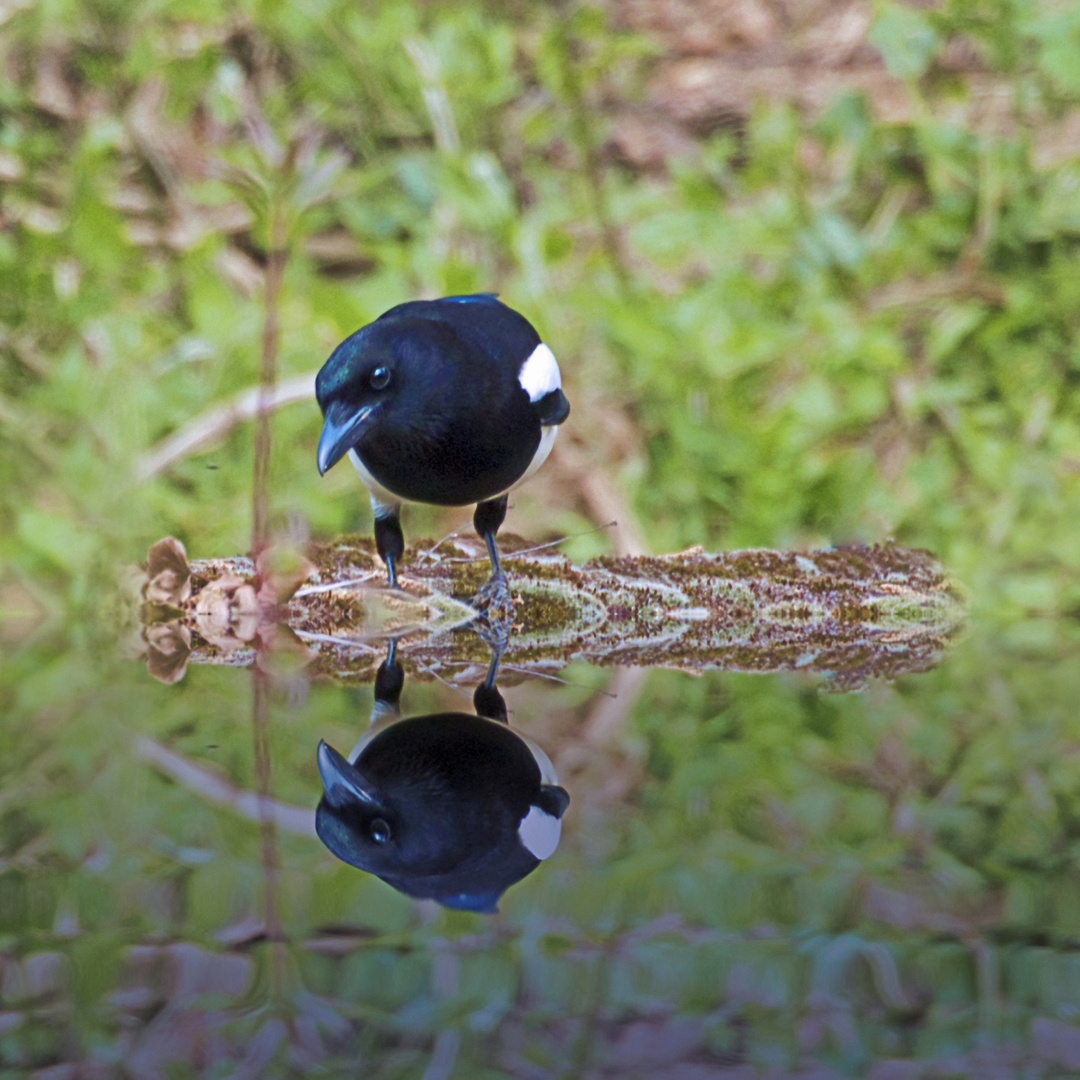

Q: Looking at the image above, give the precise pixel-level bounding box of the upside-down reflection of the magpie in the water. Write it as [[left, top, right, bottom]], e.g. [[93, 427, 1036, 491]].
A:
[[315, 646, 570, 913]]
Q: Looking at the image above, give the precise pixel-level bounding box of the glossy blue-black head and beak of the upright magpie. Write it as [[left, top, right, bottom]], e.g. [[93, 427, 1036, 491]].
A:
[[315, 316, 461, 474]]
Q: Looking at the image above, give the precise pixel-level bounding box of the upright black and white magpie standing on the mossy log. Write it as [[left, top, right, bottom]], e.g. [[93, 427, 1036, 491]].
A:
[[315, 293, 570, 588]]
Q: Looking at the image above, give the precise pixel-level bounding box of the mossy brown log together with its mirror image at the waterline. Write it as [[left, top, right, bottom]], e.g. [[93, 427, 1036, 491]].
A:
[[132, 536, 964, 689]]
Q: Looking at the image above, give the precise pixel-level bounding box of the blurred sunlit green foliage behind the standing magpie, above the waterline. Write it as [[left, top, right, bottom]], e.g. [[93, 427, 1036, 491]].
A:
[[0, 0, 1080, 630]]
